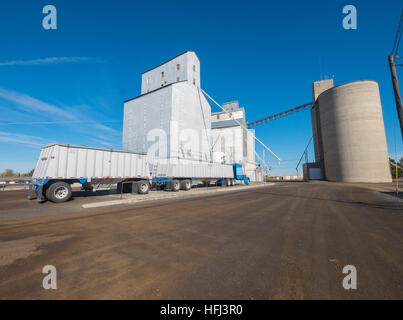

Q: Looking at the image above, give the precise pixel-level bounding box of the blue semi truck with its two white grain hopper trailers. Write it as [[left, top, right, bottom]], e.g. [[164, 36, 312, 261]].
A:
[[28, 143, 249, 203]]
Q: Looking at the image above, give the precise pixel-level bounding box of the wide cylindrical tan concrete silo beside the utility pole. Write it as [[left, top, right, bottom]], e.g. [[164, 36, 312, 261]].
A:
[[318, 81, 392, 182]]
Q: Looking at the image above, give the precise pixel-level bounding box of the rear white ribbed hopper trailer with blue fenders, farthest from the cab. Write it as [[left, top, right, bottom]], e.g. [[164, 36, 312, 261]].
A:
[[28, 143, 150, 202]]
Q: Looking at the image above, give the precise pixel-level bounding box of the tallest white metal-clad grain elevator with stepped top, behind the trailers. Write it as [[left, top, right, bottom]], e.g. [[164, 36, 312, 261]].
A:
[[123, 51, 211, 163]]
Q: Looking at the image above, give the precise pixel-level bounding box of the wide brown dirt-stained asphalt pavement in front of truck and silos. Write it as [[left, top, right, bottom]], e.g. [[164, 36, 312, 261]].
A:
[[0, 182, 403, 299]]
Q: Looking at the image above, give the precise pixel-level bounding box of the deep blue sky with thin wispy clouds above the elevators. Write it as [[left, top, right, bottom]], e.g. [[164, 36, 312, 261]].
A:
[[0, 0, 403, 173]]
